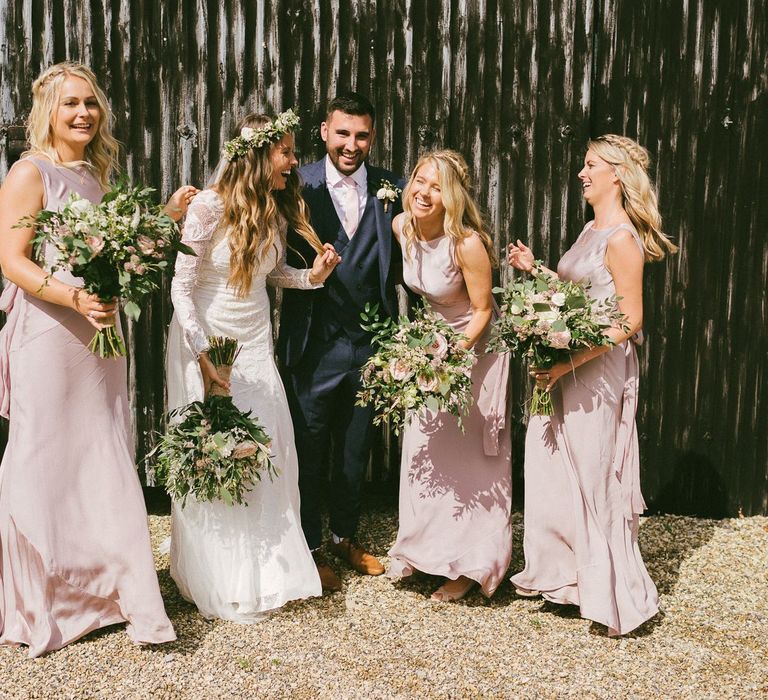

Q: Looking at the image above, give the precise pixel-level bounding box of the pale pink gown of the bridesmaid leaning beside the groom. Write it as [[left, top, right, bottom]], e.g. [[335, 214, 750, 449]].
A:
[[388, 234, 512, 596]]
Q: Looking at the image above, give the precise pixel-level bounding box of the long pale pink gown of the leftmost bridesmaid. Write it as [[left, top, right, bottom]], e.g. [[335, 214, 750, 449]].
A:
[[0, 157, 175, 657]]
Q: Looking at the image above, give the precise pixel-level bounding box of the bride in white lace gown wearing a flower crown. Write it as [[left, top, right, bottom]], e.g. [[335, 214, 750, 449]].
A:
[[167, 110, 340, 623]]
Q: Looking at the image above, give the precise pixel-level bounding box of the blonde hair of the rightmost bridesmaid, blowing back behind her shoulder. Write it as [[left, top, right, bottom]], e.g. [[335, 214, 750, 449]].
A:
[[589, 134, 678, 261]]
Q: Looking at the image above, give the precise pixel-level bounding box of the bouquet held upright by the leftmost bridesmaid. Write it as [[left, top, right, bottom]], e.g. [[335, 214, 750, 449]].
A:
[[17, 181, 194, 358]]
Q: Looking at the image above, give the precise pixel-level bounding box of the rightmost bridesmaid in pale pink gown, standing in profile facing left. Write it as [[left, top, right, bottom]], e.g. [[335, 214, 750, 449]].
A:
[[509, 134, 677, 635]]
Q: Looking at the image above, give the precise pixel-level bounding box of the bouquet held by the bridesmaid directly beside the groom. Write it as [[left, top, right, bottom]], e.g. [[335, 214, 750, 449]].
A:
[[357, 302, 475, 434]]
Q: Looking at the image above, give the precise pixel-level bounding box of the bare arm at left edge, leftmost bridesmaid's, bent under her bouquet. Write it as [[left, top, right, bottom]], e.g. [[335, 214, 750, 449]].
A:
[[0, 161, 117, 328]]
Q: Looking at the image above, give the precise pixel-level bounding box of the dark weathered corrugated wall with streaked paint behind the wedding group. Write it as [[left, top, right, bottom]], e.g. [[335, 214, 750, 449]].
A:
[[0, 0, 768, 515]]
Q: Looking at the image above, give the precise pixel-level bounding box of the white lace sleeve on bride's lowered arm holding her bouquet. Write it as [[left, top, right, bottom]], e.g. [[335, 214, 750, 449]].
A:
[[171, 191, 221, 357]]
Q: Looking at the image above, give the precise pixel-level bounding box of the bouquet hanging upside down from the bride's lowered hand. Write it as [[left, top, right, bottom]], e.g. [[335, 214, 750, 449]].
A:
[[146, 336, 278, 507]]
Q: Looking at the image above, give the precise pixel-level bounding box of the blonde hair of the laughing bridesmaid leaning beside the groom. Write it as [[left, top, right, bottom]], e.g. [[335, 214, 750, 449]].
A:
[[402, 149, 498, 267]]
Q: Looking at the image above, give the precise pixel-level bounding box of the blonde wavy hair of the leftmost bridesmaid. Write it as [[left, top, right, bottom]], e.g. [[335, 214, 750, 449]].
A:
[[23, 61, 120, 189]]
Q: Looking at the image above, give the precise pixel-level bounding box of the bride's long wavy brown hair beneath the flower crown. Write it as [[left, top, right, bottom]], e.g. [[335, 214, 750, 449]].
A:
[[215, 114, 323, 298]]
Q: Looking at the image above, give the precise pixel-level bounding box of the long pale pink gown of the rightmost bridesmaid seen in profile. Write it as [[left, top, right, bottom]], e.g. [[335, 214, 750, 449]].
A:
[[512, 222, 658, 634]]
